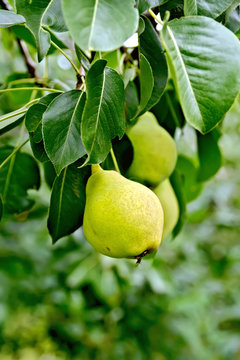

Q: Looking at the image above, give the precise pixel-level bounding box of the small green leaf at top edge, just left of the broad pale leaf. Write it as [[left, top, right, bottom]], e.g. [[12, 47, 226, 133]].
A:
[[43, 0, 68, 32]]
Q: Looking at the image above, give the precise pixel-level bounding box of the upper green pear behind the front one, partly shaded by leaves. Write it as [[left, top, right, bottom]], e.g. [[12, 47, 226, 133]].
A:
[[127, 112, 177, 185]]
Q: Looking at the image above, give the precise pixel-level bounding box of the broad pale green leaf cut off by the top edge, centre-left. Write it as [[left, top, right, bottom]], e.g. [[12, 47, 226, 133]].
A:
[[63, 0, 138, 52]]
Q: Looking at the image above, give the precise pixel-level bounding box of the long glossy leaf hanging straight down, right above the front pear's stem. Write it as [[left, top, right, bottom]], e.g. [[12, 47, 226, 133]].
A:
[[81, 60, 125, 164]]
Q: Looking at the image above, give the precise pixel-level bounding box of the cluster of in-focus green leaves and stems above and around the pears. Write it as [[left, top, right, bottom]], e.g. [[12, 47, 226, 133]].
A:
[[0, 0, 240, 242]]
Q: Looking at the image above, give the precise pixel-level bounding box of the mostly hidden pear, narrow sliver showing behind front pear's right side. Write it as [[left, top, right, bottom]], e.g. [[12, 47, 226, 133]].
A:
[[154, 179, 179, 239]]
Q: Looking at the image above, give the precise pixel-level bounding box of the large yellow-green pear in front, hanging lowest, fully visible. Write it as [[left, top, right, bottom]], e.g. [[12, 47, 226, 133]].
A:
[[83, 165, 163, 262]]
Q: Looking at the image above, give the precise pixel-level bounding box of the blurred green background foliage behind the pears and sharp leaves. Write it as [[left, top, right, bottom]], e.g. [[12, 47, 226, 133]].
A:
[[0, 28, 240, 360]]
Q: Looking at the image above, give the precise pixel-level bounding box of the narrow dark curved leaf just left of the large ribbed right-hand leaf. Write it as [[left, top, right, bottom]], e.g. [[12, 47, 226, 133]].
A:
[[139, 17, 168, 111]]
